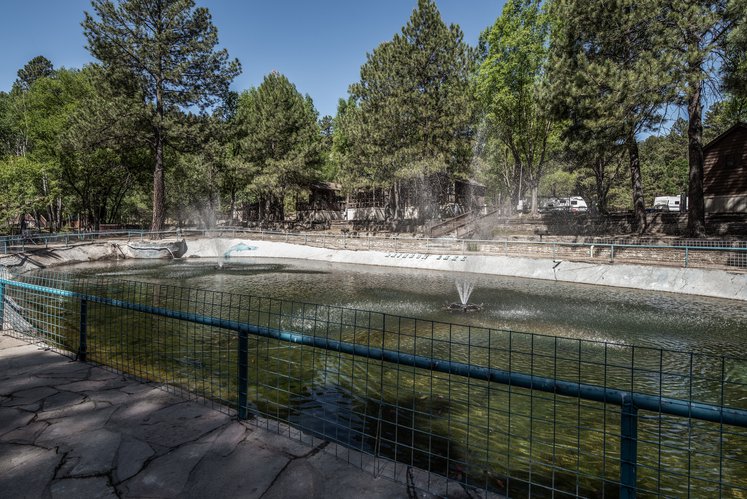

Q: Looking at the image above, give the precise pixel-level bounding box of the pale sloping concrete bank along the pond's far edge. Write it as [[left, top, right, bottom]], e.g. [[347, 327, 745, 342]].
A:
[[0, 238, 747, 301]]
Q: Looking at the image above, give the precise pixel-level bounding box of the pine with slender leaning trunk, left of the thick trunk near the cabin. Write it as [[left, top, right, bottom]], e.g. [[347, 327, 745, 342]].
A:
[[550, 0, 672, 232]]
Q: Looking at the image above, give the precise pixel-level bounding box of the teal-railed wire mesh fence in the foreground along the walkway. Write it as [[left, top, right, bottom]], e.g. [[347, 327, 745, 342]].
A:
[[0, 274, 747, 497]]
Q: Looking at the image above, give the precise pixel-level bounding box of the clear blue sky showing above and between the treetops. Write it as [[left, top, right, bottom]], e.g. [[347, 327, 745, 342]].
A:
[[0, 0, 504, 115]]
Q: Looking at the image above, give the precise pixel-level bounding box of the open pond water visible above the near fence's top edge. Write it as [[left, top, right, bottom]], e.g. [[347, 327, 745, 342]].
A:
[[60, 259, 747, 357]]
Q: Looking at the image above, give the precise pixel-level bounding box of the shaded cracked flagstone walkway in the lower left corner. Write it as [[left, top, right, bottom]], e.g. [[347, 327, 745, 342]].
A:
[[0, 334, 479, 499]]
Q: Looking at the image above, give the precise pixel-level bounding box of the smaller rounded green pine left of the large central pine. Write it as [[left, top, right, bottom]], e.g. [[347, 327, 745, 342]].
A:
[[234, 72, 322, 219]]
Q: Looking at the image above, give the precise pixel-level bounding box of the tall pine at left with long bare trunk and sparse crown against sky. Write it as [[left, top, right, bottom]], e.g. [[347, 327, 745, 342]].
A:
[[83, 0, 240, 231]]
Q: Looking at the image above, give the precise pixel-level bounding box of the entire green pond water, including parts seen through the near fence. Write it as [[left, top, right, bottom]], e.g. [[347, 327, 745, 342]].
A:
[[51, 259, 747, 497]]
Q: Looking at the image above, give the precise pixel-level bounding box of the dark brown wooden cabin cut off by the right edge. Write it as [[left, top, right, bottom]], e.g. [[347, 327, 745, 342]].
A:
[[703, 123, 747, 213]]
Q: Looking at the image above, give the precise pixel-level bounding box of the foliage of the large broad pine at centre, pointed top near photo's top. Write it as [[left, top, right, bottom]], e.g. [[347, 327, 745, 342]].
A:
[[334, 0, 475, 199]]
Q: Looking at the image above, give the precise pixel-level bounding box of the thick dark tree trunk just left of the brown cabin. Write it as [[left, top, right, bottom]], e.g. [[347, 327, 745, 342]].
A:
[[687, 83, 705, 237]]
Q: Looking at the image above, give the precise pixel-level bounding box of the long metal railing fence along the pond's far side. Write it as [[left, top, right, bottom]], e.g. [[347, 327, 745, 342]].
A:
[[5, 228, 747, 270]]
